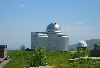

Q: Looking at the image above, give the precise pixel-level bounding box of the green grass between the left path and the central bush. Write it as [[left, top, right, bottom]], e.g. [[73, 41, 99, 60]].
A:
[[4, 50, 34, 68]]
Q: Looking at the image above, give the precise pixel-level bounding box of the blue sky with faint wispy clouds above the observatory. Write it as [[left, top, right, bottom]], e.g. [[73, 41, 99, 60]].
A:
[[0, 0, 100, 49]]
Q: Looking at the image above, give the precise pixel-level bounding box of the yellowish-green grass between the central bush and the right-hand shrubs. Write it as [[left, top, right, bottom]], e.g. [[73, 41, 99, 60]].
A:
[[47, 52, 69, 66]]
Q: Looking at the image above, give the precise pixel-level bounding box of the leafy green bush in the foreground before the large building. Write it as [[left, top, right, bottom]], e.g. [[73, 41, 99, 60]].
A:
[[30, 47, 47, 67]]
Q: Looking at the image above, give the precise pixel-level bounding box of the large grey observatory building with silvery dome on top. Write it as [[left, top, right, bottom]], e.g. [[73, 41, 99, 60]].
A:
[[31, 23, 69, 51]]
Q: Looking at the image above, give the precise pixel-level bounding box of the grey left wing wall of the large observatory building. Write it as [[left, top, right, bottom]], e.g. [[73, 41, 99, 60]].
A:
[[31, 33, 48, 50]]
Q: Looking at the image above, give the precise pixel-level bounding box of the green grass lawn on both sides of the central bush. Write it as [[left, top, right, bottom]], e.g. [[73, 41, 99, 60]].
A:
[[4, 50, 69, 68]]
